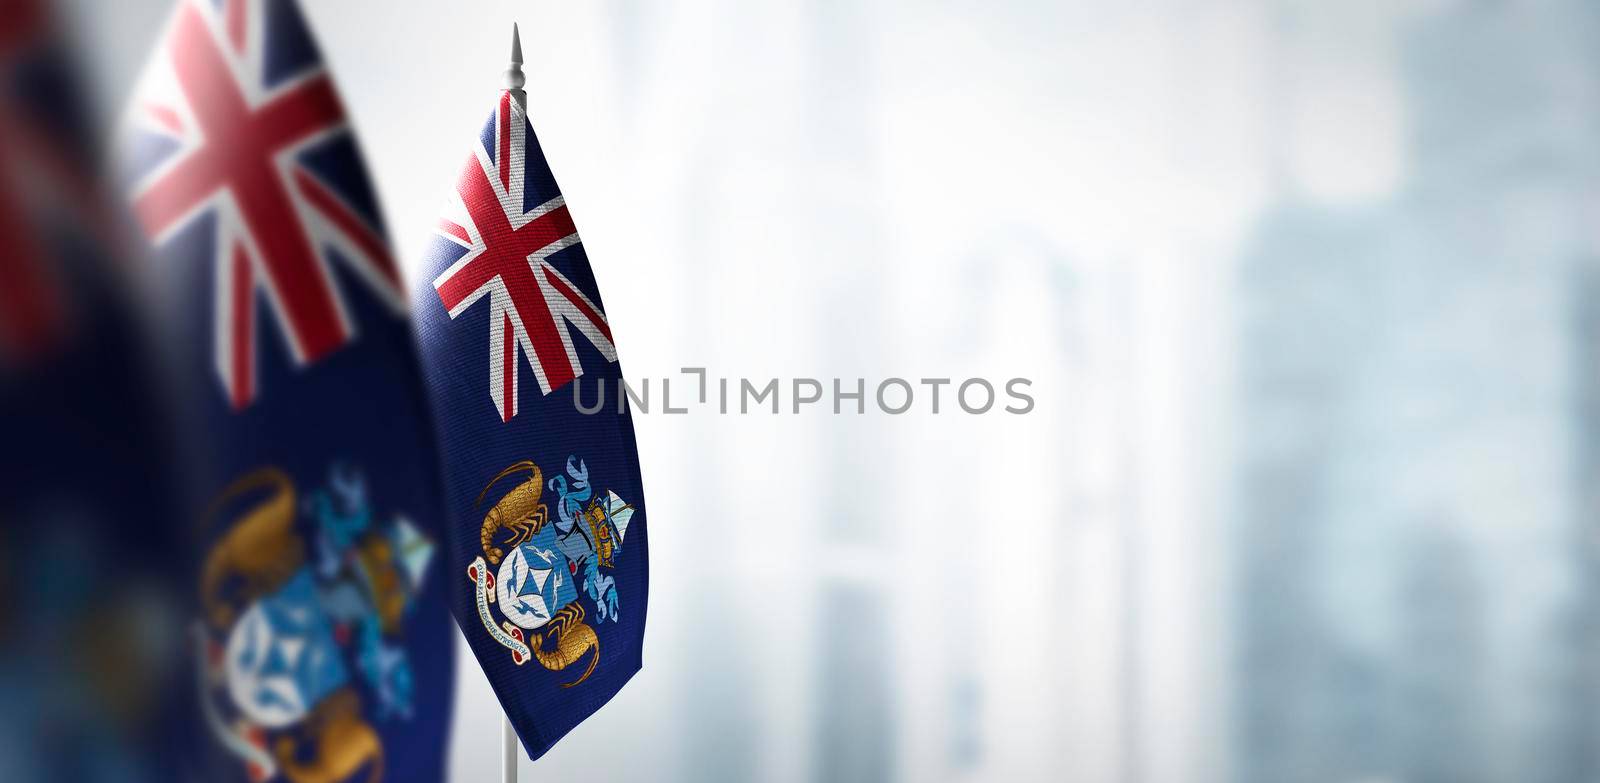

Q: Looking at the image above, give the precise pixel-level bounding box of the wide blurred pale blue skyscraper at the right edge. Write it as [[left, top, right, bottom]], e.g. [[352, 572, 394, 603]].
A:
[[1234, 0, 1600, 783]]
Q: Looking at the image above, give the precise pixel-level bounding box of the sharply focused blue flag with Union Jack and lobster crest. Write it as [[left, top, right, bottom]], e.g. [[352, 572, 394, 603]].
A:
[[413, 91, 648, 757]]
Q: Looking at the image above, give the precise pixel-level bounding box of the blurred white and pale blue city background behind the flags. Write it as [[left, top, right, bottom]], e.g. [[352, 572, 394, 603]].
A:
[[15, 0, 1600, 783]]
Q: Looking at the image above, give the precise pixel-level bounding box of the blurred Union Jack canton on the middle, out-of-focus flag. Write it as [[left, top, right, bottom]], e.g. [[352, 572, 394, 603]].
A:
[[128, 0, 405, 410]]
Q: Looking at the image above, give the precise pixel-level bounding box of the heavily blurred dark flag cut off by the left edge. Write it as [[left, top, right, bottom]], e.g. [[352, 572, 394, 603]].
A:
[[0, 0, 186, 781]]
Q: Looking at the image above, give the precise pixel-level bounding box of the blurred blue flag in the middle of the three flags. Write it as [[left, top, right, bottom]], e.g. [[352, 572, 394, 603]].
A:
[[122, 0, 454, 781]]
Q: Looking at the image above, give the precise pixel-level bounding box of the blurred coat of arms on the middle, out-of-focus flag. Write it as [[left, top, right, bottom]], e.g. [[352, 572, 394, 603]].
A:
[[195, 468, 434, 783]]
